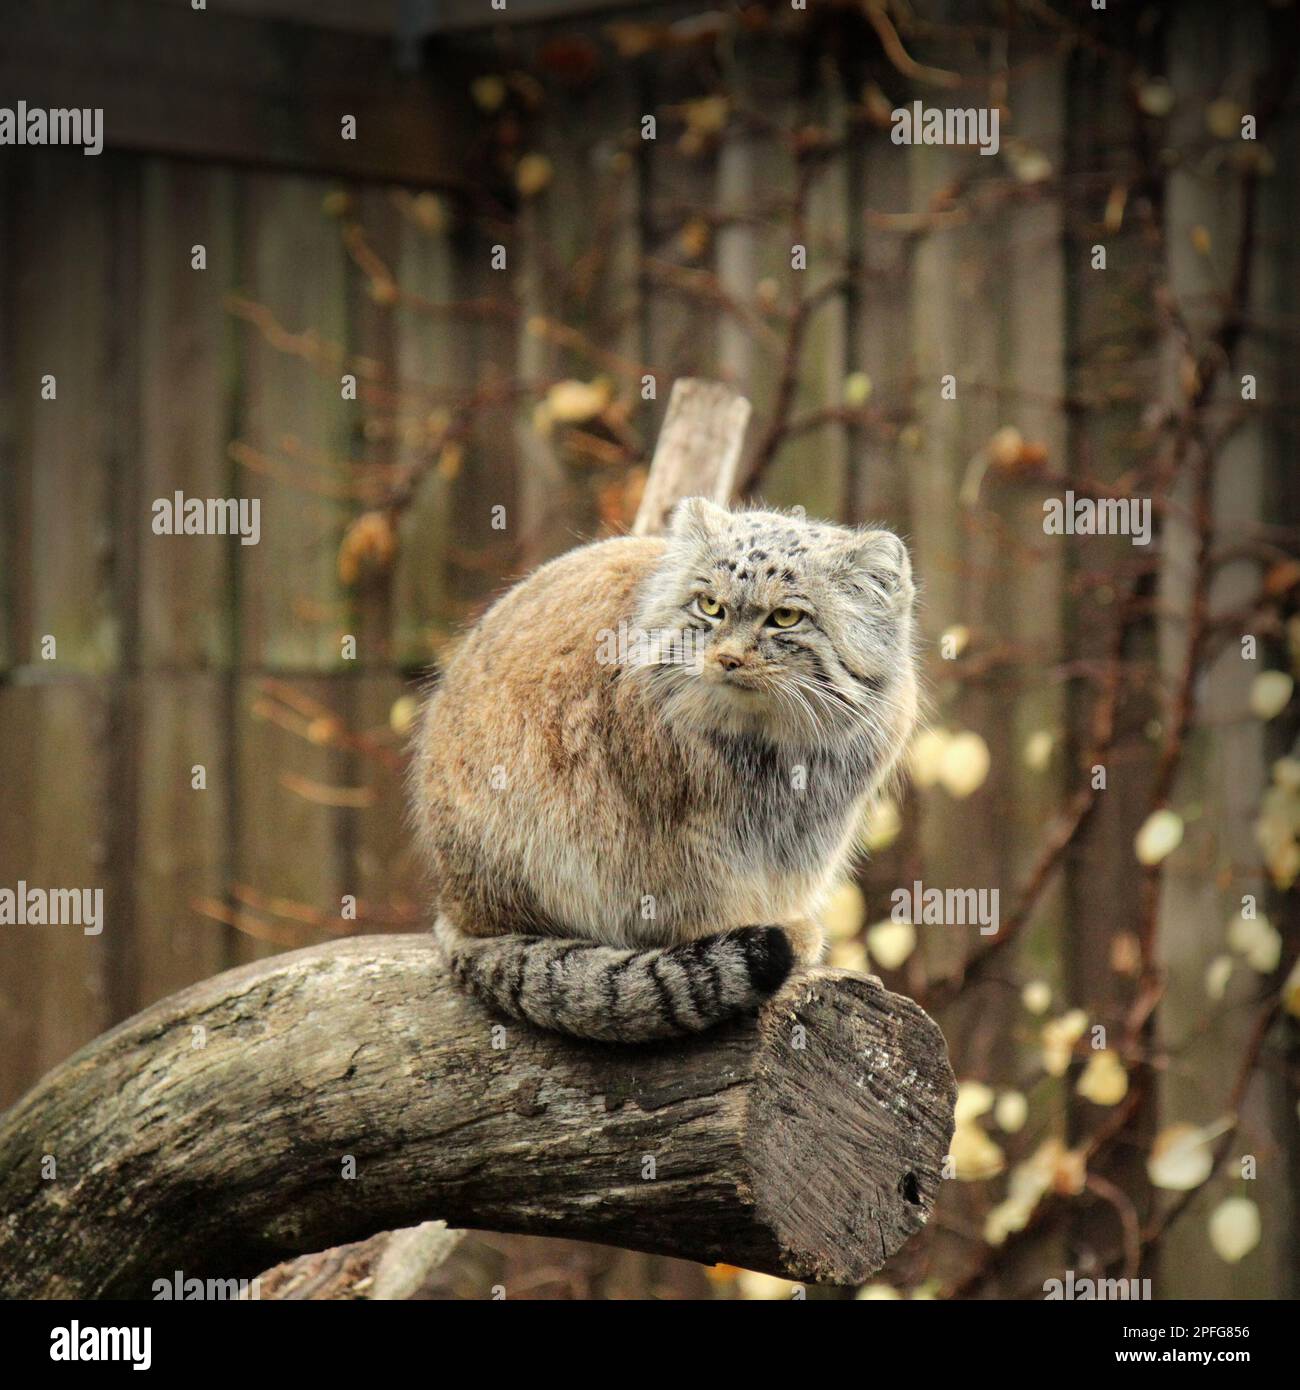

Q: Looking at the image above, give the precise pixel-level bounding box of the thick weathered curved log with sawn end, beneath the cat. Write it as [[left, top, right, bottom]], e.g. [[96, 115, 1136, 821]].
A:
[[0, 935, 954, 1297]]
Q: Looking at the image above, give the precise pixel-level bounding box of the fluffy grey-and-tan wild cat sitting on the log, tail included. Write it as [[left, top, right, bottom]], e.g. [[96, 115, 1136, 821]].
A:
[[412, 498, 918, 1041]]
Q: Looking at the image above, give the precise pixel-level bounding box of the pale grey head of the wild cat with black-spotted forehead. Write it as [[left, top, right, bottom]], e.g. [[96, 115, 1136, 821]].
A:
[[635, 498, 916, 742]]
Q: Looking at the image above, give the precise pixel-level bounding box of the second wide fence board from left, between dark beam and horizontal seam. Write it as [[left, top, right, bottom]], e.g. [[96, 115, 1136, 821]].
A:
[[138, 160, 247, 667]]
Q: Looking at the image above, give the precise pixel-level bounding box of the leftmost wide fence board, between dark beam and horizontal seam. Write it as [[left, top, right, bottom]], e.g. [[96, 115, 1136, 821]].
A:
[[11, 153, 120, 671]]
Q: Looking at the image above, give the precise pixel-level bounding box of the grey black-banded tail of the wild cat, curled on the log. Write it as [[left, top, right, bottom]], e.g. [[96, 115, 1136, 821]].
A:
[[434, 917, 794, 1043]]
